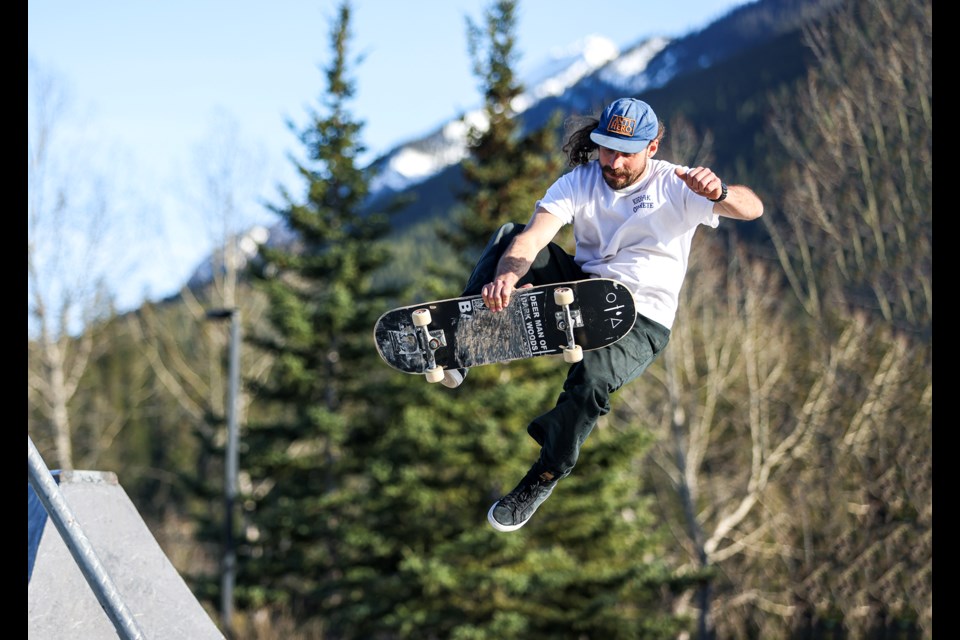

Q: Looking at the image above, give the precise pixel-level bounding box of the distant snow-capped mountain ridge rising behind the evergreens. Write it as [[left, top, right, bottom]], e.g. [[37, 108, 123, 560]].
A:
[[190, 0, 843, 286]]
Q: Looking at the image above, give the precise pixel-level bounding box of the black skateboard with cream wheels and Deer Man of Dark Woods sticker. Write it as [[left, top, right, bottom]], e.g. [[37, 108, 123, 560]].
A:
[[373, 278, 637, 382]]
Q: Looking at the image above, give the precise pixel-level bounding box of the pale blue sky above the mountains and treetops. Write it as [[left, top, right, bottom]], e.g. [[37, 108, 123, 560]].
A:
[[27, 0, 744, 306]]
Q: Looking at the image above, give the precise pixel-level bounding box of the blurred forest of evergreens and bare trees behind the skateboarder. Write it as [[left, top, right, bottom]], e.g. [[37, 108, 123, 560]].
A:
[[28, 0, 933, 640]]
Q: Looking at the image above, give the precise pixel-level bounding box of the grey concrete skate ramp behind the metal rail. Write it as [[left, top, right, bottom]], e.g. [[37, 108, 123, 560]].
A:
[[27, 471, 224, 640]]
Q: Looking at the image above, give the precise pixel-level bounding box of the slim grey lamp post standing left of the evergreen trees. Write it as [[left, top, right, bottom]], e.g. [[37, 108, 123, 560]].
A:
[[207, 309, 240, 637]]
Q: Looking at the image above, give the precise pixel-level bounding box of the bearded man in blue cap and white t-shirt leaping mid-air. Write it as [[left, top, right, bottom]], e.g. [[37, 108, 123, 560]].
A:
[[442, 98, 763, 531]]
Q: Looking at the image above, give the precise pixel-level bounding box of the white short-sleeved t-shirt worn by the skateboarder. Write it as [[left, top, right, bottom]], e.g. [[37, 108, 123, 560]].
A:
[[537, 159, 720, 329]]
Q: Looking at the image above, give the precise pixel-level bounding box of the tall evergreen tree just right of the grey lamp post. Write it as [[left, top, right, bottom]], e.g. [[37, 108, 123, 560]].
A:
[[237, 2, 400, 620]]
